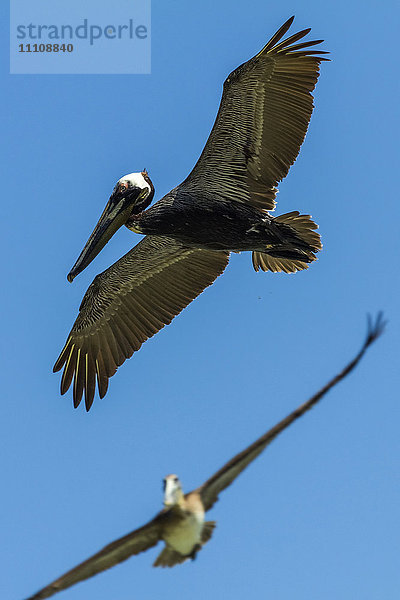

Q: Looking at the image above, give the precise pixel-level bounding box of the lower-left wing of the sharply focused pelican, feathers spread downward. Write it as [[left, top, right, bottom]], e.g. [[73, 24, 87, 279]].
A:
[[54, 236, 229, 410]]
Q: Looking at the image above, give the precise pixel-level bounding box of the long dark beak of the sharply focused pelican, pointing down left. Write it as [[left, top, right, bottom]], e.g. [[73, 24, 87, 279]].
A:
[[67, 188, 146, 282]]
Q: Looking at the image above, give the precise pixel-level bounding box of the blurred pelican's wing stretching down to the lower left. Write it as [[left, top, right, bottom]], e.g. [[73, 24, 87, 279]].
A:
[[27, 512, 165, 600]]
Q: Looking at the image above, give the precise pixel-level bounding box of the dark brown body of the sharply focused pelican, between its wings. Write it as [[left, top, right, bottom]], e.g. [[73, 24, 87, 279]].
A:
[[126, 187, 320, 255]]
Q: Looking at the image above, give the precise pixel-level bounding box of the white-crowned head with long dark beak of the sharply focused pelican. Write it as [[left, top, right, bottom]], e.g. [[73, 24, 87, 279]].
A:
[[67, 170, 154, 282]]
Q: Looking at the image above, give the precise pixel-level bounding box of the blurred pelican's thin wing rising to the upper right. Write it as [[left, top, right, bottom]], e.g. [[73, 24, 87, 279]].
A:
[[195, 313, 385, 510]]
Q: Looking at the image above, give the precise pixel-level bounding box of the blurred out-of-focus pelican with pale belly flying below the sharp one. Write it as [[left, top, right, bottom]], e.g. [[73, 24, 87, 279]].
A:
[[28, 313, 385, 600]]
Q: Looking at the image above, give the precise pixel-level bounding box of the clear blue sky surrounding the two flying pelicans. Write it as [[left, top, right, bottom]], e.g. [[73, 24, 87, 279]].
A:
[[0, 0, 400, 600]]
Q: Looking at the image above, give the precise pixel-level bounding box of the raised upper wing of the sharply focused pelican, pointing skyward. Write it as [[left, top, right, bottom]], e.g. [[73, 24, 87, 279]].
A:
[[181, 17, 326, 210]]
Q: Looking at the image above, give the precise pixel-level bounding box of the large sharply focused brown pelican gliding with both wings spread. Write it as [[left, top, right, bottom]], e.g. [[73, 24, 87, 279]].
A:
[[54, 17, 326, 410]]
